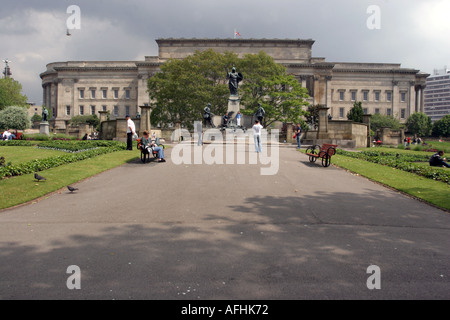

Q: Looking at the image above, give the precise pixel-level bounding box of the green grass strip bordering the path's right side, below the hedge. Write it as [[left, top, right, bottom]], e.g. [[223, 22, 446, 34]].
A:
[[332, 155, 450, 211]]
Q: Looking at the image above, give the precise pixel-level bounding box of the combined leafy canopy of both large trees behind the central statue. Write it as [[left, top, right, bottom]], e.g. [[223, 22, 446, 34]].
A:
[[148, 50, 308, 127]]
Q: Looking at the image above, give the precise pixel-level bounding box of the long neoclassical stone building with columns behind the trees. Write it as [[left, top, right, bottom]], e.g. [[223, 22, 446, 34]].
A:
[[40, 38, 429, 129]]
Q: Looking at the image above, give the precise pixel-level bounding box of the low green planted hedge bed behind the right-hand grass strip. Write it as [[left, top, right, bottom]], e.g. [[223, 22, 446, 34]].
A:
[[337, 149, 450, 184]]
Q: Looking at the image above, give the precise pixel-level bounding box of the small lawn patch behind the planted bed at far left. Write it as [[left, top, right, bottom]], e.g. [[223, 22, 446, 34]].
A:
[[0, 146, 64, 165]]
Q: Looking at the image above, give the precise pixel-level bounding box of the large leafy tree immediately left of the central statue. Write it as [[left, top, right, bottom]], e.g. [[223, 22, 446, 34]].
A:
[[148, 50, 234, 127]]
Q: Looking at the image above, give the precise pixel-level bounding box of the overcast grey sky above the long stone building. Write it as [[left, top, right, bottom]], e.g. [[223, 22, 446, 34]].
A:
[[0, 0, 450, 104]]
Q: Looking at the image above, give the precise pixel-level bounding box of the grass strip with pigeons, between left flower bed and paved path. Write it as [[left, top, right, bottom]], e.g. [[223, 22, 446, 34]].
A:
[[0, 150, 138, 210]]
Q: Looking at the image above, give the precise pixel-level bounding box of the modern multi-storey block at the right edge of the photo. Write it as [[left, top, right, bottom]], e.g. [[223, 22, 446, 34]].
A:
[[425, 68, 450, 122]]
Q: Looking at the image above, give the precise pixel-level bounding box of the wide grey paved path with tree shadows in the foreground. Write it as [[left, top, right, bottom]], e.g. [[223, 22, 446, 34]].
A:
[[0, 148, 450, 299]]
